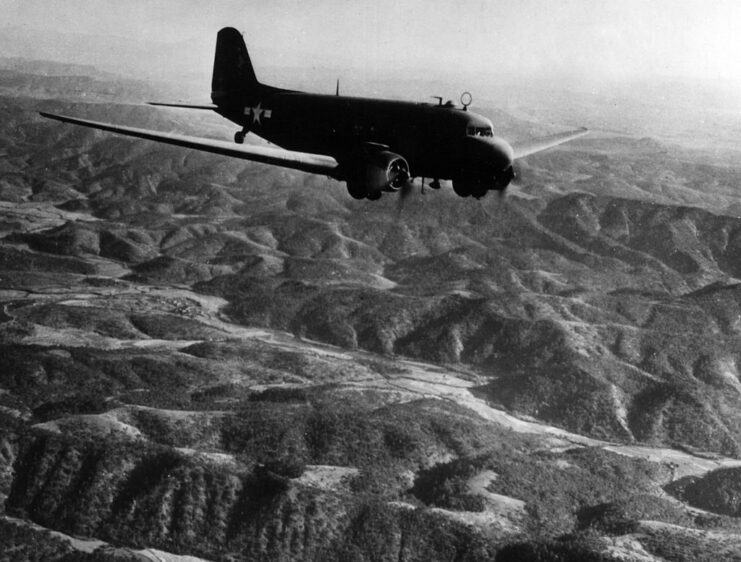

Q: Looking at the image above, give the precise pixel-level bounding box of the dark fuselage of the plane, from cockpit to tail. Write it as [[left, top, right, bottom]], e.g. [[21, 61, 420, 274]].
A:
[[217, 90, 511, 179]]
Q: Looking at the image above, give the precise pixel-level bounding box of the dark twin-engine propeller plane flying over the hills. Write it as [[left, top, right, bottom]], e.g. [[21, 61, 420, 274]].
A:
[[41, 27, 587, 200]]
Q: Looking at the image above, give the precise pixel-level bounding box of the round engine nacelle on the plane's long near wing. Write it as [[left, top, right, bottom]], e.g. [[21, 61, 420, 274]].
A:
[[346, 150, 410, 199]]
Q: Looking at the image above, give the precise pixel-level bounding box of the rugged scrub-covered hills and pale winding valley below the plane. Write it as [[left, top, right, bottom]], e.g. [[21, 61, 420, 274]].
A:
[[0, 61, 741, 561]]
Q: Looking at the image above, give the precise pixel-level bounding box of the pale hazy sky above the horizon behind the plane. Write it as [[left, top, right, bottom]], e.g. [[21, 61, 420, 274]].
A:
[[0, 0, 741, 84]]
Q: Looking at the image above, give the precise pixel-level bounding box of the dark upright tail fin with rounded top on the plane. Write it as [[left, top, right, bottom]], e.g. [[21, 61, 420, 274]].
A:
[[211, 27, 260, 105]]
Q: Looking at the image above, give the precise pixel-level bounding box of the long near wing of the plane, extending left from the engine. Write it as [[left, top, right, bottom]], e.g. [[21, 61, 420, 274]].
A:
[[39, 111, 339, 177]]
